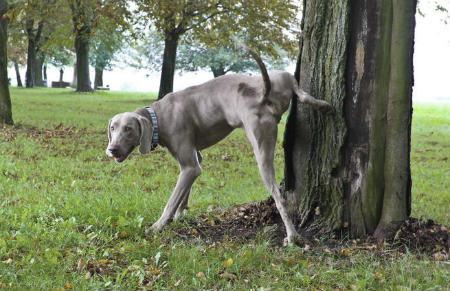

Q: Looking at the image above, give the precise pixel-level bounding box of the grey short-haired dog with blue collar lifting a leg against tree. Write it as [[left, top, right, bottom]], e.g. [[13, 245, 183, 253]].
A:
[[106, 45, 332, 244]]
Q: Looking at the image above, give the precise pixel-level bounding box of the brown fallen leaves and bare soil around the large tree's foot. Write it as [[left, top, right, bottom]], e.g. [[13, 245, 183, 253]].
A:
[[172, 197, 450, 259]]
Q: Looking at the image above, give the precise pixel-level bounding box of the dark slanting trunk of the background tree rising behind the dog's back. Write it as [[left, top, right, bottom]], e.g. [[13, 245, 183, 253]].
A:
[[158, 33, 179, 99]]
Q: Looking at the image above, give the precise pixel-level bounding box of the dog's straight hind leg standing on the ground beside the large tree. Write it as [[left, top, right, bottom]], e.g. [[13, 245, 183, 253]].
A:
[[244, 115, 299, 245]]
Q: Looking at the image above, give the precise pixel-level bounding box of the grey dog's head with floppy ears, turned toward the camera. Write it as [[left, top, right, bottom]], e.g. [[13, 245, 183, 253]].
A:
[[106, 112, 153, 163]]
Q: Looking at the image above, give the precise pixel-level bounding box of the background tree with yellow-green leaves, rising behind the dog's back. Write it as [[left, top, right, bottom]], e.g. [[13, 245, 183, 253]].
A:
[[135, 0, 298, 99]]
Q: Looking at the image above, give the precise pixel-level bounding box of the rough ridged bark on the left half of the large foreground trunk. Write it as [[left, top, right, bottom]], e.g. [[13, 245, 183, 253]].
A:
[[285, 0, 349, 231]]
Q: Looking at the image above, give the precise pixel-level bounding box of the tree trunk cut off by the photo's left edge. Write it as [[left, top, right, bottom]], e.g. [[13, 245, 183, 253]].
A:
[[0, 0, 14, 125]]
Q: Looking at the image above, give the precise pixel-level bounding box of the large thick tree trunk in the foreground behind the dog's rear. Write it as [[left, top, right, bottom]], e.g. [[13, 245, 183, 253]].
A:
[[284, 0, 415, 238]]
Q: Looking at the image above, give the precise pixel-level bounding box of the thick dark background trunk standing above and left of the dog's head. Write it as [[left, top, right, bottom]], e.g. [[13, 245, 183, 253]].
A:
[[75, 30, 92, 92]]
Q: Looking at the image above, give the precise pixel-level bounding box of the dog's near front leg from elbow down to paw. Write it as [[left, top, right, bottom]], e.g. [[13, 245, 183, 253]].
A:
[[149, 150, 202, 231]]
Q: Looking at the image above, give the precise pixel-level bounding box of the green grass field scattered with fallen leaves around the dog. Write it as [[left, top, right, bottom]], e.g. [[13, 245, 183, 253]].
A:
[[0, 88, 450, 290]]
